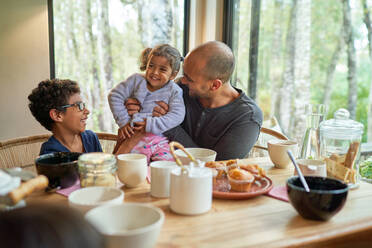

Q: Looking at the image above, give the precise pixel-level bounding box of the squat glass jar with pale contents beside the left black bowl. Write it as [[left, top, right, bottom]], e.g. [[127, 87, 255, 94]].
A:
[[78, 152, 117, 187]]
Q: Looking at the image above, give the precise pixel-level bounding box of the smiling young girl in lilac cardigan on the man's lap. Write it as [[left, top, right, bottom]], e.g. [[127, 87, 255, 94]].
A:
[[108, 44, 185, 162]]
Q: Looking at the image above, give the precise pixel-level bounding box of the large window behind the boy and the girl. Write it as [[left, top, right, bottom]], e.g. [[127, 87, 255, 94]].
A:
[[49, 0, 187, 132]]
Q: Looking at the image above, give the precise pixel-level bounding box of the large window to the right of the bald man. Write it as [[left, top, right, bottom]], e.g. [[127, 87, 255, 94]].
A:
[[228, 0, 372, 142]]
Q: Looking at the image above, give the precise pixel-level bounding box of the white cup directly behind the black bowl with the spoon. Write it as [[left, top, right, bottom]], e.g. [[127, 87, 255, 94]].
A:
[[294, 159, 327, 177]]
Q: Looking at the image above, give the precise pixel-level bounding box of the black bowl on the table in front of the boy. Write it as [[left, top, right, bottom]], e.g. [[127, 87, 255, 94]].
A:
[[35, 152, 81, 189]]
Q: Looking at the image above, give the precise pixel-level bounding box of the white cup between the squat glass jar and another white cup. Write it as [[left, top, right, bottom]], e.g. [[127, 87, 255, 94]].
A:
[[117, 153, 147, 188]]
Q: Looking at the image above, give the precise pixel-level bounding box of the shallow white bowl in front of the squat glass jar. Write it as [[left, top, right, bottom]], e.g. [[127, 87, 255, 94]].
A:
[[68, 186, 124, 213]]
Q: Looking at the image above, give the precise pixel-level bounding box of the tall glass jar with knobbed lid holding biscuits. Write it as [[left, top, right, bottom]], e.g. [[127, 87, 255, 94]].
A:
[[319, 109, 364, 187]]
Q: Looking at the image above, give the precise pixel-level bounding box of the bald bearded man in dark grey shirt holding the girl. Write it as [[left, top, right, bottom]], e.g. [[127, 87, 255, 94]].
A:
[[126, 41, 262, 160]]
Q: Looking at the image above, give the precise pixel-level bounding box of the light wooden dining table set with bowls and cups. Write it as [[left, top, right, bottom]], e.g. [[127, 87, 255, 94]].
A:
[[26, 157, 372, 248]]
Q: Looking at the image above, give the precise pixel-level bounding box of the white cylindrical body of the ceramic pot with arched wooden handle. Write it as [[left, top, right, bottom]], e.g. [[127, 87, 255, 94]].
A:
[[170, 166, 213, 215]]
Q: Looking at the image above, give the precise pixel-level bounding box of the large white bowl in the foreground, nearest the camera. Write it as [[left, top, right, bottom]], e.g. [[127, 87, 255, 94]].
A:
[[85, 203, 164, 248]]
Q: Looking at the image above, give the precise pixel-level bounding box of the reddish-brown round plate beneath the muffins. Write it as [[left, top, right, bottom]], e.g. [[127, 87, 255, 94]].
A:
[[213, 177, 273, 200]]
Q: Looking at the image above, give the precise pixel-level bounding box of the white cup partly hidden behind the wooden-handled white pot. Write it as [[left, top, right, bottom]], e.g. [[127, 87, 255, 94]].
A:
[[150, 161, 177, 197]]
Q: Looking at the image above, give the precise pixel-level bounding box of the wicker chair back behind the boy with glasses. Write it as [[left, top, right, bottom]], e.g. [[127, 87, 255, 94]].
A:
[[0, 133, 116, 168]]
